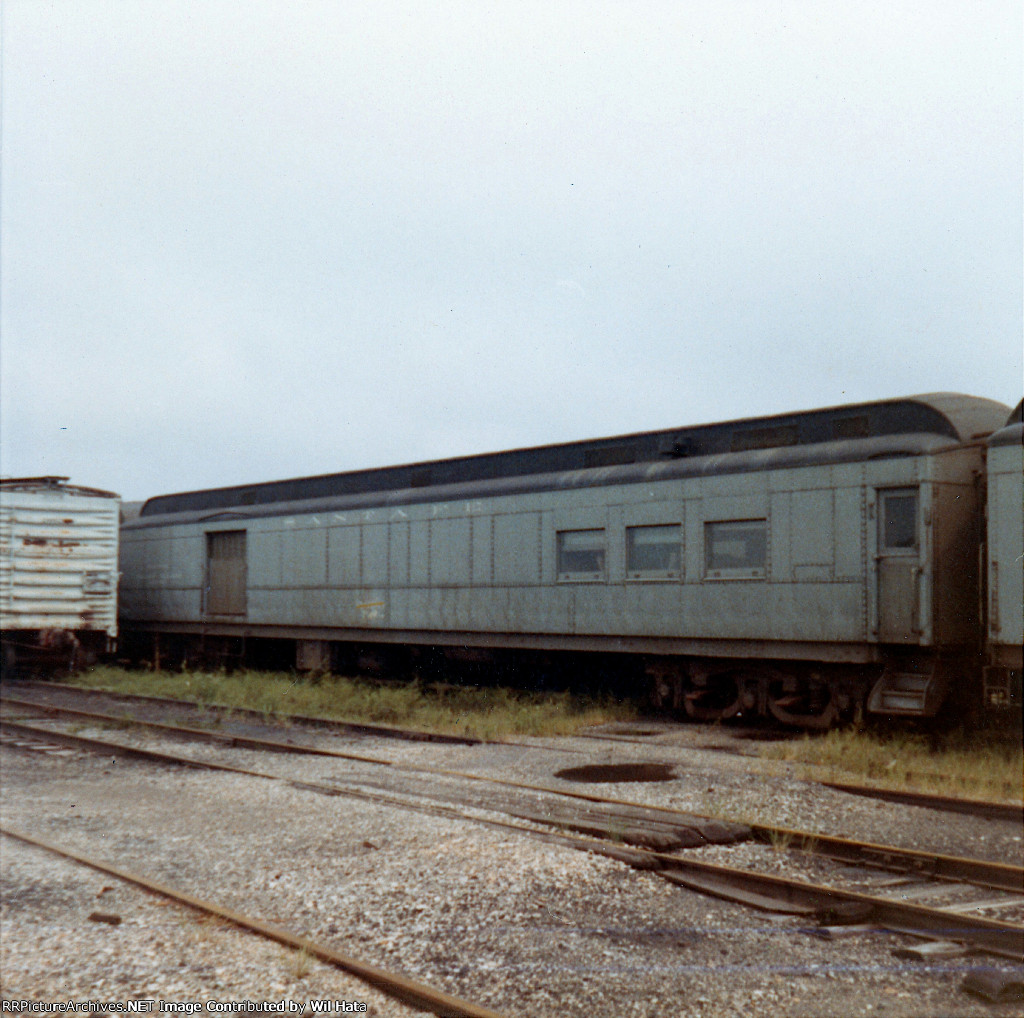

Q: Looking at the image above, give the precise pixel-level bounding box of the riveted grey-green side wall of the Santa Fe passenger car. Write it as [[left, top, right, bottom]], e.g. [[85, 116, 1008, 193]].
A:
[[123, 446, 970, 653]]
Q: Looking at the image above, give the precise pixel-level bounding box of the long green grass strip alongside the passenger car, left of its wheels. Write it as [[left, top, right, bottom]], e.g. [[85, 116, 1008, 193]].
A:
[[64, 667, 637, 739]]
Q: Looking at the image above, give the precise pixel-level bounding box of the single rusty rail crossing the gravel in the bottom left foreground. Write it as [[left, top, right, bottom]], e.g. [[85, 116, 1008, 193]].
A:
[[0, 826, 502, 1018]]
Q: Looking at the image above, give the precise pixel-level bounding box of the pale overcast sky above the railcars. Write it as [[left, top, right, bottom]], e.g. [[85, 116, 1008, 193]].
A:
[[0, 0, 1024, 499]]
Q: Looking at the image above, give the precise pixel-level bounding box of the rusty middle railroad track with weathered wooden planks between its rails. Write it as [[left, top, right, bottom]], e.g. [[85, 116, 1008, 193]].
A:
[[2, 704, 1024, 961]]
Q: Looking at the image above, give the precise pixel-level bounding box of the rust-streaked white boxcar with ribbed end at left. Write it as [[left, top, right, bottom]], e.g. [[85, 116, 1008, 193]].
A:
[[0, 477, 120, 670]]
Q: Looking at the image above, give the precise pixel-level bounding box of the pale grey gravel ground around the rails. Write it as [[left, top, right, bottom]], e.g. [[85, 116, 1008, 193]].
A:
[[0, 712, 1021, 1018]]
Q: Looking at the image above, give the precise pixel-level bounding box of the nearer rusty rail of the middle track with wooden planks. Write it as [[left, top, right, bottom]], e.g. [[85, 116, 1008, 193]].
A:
[[0, 722, 1024, 962]]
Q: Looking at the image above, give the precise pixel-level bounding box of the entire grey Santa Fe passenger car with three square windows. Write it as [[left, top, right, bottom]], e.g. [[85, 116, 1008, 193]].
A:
[[122, 394, 1009, 726]]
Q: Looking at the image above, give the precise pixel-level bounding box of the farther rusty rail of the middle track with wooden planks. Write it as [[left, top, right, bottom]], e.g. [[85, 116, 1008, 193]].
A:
[[0, 697, 1024, 892]]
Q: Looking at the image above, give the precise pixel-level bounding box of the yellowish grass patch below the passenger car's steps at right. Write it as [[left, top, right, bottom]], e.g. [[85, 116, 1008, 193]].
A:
[[761, 727, 1024, 802]]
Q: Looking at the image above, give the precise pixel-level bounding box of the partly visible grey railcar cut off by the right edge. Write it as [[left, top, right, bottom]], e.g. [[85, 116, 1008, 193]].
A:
[[984, 404, 1024, 707]]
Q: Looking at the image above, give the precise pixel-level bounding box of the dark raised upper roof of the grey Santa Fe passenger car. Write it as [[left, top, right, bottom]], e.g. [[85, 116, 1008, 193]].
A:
[[140, 392, 1010, 517]]
